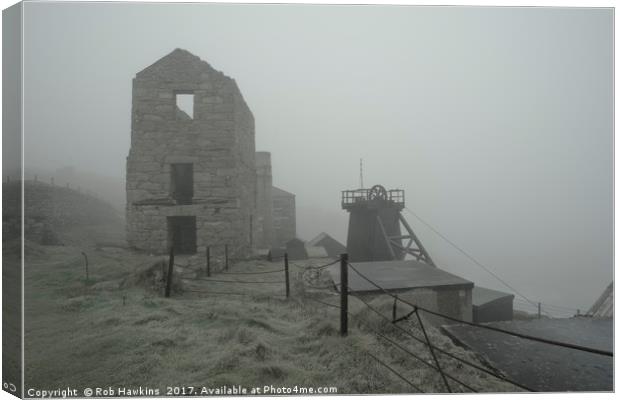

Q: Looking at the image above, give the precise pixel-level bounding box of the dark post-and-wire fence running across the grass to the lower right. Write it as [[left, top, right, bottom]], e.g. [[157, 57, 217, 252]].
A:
[[160, 253, 613, 393]]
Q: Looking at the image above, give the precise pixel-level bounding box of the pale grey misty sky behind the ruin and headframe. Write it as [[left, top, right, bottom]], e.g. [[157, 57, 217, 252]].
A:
[[17, 3, 613, 310]]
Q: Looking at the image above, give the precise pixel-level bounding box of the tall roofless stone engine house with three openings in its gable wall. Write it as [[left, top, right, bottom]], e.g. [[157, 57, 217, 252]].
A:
[[126, 49, 257, 255]]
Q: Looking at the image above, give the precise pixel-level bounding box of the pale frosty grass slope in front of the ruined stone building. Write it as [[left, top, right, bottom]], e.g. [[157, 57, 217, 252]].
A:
[[25, 239, 517, 394]]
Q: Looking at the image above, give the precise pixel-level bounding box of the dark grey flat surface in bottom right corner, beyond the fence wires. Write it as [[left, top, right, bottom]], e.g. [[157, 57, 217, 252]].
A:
[[444, 318, 613, 392]]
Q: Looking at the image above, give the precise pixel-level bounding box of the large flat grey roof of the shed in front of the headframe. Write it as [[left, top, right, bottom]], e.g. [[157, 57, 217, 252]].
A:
[[329, 260, 474, 292]]
